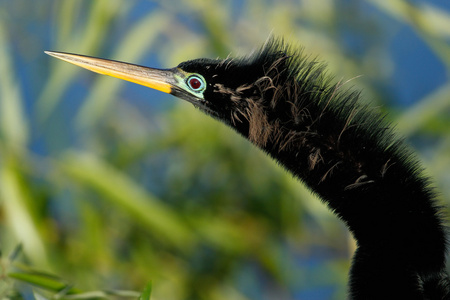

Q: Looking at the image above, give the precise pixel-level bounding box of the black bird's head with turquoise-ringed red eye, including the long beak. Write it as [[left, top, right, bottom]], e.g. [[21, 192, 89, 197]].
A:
[[46, 42, 296, 142]]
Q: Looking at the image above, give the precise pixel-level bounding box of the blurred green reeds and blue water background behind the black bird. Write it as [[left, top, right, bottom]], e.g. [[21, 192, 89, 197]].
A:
[[0, 0, 450, 300]]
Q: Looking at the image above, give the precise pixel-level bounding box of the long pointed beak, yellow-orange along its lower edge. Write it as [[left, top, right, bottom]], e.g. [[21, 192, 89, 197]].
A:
[[45, 51, 181, 94]]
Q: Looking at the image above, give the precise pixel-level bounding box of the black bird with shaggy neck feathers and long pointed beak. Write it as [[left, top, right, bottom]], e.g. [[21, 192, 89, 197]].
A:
[[47, 39, 450, 300]]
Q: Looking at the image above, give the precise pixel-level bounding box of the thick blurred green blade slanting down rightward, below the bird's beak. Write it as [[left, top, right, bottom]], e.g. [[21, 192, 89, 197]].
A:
[[60, 152, 194, 251]]
